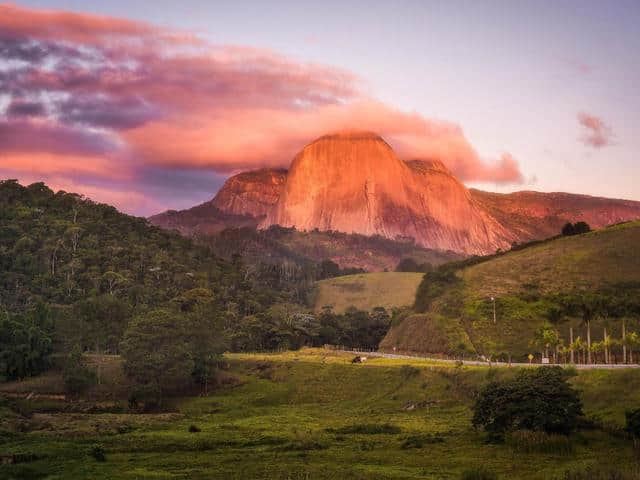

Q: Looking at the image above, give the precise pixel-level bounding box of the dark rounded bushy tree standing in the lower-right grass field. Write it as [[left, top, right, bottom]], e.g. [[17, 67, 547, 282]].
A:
[[472, 367, 582, 439]]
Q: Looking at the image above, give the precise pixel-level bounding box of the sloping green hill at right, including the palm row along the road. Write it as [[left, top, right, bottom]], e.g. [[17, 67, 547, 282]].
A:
[[381, 221, 640, 363]]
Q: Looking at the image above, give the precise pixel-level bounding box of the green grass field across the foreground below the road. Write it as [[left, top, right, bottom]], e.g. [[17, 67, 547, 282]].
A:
[[0, 349, 640, 480]]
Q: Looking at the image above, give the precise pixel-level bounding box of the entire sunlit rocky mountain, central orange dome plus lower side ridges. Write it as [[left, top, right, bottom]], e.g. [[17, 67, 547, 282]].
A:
[[150, 131, 640, 255]]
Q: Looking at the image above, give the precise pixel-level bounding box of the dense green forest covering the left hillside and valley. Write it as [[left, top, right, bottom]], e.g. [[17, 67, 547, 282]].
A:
[[0, 180, 390, 390]]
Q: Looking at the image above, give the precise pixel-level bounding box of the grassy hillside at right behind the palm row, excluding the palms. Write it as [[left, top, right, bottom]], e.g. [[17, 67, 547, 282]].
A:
[[381, 221, 640, 360]]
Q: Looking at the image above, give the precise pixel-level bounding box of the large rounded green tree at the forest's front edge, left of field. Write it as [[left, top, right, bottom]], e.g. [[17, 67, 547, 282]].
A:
[[121, 309, 194, 403]]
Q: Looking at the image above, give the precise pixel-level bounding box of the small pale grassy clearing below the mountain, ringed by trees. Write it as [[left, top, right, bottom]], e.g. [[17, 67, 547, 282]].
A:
[[312, 272, 424, 313]]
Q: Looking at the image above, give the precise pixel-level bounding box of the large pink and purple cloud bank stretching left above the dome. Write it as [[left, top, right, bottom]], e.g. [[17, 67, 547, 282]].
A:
[[0, 5, 522, 211]]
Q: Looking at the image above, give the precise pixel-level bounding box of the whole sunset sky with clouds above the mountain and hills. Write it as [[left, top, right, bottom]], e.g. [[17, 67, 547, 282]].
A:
[[0, 0, 640, 215]]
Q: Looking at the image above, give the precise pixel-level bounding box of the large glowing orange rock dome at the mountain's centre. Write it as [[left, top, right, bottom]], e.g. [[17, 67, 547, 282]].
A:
[[261, 132, 511, 253]]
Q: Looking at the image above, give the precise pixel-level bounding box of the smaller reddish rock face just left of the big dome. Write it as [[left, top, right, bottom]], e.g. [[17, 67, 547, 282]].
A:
[[211, 168, 287, 217]]
